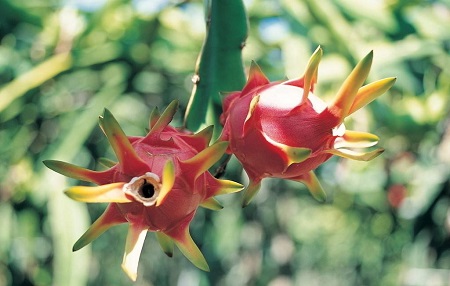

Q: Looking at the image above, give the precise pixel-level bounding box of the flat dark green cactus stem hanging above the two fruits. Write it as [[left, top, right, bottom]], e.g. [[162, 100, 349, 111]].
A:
[[185, 0, 247, 138]]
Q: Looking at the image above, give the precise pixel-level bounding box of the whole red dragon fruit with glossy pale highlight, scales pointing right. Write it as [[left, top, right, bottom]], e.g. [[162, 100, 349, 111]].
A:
[[220, 47, 396, 206]]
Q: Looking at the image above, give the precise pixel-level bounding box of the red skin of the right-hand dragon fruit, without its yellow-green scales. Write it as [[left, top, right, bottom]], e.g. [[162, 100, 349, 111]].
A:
[[221, 83, 339, 182]]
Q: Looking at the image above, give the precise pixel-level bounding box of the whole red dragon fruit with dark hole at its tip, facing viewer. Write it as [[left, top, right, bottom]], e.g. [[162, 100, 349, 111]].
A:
[[44, 101, 243, 281]]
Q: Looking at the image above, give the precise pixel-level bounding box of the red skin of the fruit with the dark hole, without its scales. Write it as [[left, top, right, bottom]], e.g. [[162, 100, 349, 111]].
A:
[[90, 126, 214, 235]]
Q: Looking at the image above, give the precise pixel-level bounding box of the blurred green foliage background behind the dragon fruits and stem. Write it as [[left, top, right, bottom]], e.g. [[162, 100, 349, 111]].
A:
[[0, 0, 450, 286]]
